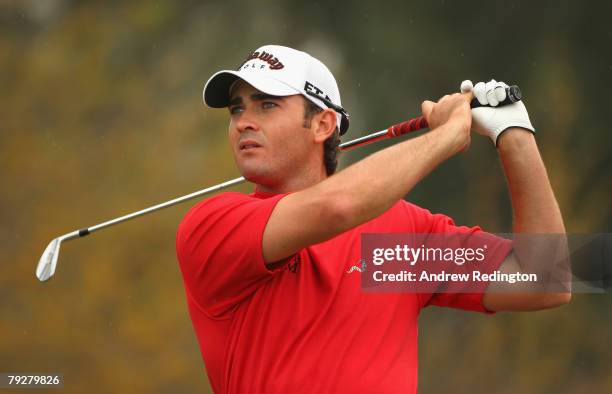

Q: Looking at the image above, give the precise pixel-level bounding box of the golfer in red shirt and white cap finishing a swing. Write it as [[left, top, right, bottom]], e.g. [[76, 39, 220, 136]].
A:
[[177, 45, 569, 393]]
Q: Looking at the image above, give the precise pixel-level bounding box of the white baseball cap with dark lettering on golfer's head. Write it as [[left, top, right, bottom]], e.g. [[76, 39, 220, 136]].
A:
[[202, 45, 349, 135]]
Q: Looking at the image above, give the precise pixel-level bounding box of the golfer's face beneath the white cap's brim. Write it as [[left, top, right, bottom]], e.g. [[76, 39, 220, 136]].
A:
[[228, 80, 314, 188]]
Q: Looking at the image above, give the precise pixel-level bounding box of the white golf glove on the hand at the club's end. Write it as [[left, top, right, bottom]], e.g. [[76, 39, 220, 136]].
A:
[[461, 79, 535, 146]]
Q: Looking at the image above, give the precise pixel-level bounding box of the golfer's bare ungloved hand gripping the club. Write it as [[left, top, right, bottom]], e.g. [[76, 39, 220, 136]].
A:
[[421, 91, 473, 155]]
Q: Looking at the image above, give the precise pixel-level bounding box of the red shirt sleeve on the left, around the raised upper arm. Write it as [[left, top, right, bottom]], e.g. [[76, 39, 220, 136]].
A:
[[176, 193, 285, 317]]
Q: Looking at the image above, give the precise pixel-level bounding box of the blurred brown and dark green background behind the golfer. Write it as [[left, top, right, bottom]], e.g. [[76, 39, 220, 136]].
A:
[[0, 0, 612, 393]]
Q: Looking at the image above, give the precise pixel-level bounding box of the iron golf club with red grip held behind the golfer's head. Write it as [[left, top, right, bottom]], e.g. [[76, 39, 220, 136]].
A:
[[36, 85, 521, 282]]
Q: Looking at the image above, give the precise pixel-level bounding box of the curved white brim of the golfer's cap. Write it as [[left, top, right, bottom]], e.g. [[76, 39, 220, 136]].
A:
[[202, 70, 301, 108]]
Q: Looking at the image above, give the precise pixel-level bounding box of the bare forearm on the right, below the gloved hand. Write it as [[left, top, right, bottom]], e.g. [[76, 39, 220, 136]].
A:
[[498, 128, 571, 309]]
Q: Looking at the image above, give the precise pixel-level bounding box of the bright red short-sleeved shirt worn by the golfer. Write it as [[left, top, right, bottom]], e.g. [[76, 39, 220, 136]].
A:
[[176, 193, 511, 394]]
